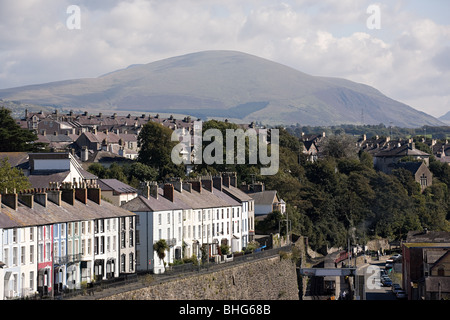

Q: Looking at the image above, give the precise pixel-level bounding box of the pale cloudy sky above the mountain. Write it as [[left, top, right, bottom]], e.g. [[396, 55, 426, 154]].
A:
[[0, 0, 450, 117]]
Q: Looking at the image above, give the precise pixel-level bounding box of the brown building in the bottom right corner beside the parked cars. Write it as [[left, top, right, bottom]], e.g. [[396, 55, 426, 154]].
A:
[[402, 230, 450, 300]]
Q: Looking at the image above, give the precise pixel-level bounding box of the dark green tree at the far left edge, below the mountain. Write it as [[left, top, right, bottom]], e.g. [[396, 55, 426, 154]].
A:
[[0, 108, 38, 152]]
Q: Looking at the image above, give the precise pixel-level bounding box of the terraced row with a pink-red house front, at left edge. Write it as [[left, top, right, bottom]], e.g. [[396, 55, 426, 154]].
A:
[[0, 183, 135, 299]]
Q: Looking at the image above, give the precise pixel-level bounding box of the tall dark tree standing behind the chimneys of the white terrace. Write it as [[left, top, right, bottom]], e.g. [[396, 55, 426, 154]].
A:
[[137, 121, 185, 179]]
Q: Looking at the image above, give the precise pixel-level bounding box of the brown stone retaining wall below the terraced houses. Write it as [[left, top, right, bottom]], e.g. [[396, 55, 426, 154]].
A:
[[104, 256, 299, 300]]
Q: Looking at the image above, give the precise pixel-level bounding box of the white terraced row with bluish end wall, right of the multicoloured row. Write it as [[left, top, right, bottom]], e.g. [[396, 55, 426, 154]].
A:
[[122, 174, 254, 273]]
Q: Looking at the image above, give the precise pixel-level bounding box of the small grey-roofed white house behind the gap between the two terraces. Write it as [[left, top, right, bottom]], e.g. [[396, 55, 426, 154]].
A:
[[98, 179, 138, 207]]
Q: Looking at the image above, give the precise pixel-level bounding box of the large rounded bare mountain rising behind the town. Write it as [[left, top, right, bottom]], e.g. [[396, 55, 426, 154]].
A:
[[0, 51, 442, 127]]
